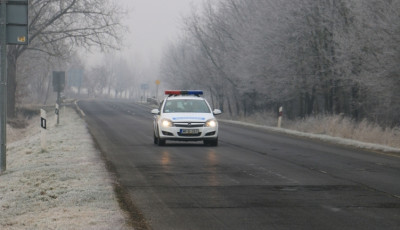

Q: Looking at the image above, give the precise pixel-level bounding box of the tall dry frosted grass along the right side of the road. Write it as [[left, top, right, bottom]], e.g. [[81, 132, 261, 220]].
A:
[[222, 112, 400, 149]]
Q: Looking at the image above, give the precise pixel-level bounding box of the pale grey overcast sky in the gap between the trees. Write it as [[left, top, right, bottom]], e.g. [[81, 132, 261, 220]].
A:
[[123, 0, 202, 58]]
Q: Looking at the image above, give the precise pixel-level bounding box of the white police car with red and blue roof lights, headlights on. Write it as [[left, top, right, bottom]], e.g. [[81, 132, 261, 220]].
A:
[[151, 90, 221, 146]]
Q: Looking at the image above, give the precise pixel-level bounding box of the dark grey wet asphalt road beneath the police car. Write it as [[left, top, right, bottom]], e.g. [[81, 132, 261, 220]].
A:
[[79, 100, 400, 230]]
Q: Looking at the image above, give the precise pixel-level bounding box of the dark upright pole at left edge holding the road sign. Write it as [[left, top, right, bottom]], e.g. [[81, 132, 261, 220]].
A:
[[0, 0, 7, 173]]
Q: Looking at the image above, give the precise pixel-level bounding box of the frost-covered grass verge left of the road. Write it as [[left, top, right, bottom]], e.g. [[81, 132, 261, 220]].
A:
[[0, 108, 129, 229]]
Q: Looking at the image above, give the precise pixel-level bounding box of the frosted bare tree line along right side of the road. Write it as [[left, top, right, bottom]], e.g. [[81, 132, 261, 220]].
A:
[[161, 0, 400, 126]]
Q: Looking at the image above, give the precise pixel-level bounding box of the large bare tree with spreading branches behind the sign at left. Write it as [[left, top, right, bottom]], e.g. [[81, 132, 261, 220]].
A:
[[7, 0, 122, 117]]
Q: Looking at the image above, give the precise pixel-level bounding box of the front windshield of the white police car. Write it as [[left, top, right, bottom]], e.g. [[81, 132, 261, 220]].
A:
[[164, 99, 210, 113]]
